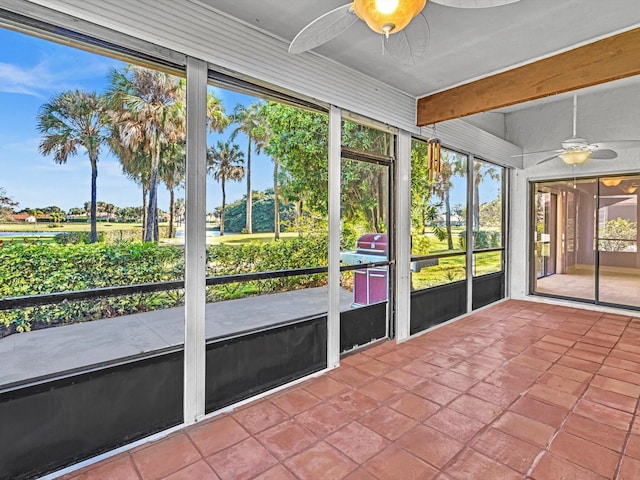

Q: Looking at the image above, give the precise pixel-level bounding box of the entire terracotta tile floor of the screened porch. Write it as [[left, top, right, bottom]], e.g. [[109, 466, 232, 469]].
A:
[[58, 301, 640, 480]]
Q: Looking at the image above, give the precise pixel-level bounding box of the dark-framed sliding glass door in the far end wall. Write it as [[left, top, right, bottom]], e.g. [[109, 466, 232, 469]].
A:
[[531, 176, 640, 308]]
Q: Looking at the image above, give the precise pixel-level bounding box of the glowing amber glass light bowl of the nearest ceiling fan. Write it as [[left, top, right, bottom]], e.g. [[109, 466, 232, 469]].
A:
[[353, 0, 427, 35]]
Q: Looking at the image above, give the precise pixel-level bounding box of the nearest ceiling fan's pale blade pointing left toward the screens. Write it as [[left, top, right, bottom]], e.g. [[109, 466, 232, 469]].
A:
[[289, 3, 358, 53]]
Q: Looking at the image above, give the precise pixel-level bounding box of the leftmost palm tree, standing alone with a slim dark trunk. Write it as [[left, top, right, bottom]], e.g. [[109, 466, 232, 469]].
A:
[[36, 90, 106, 243]]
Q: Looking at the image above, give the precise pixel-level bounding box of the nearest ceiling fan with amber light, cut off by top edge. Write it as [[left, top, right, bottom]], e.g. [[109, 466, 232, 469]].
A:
[[289, 0, 519, 65]]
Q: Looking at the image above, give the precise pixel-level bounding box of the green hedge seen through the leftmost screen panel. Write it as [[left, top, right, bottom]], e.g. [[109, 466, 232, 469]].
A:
[[0, 242, 184, 335]]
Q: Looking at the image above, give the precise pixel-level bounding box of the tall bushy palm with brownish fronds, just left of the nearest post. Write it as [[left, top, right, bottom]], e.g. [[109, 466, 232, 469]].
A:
[[108, 65, 186, 241]]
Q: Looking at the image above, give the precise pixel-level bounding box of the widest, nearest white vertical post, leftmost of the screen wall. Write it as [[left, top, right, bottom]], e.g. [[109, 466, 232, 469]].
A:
[[184, 57, 207, 424]]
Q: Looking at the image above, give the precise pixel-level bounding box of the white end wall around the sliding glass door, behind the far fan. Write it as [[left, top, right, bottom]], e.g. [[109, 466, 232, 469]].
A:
[[506, 85, 640, 299]]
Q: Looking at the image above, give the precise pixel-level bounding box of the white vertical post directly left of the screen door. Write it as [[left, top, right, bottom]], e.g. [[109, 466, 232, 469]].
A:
[[327, 106, 342, 368]]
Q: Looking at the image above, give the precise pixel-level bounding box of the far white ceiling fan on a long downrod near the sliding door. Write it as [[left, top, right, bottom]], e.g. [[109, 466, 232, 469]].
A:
[[516, 95, 640, 165]]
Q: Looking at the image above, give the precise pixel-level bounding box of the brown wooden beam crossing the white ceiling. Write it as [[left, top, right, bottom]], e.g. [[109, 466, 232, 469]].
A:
[[416, 28, 640, 127]]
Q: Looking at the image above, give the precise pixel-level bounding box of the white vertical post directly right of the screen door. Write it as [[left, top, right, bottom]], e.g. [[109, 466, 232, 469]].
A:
[[395, 130, 411, 342]]
